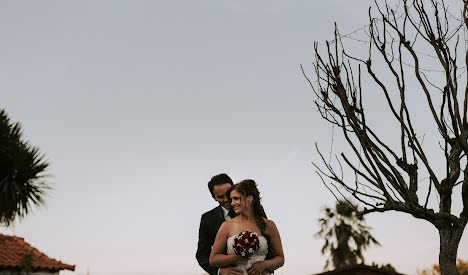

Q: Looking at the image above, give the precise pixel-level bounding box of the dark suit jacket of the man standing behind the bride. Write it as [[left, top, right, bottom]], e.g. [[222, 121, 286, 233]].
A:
[[196, 205, 224, 275]]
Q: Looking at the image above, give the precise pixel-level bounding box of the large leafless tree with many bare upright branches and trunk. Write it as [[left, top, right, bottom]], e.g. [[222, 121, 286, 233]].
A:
[[304, 0, 468, 275]]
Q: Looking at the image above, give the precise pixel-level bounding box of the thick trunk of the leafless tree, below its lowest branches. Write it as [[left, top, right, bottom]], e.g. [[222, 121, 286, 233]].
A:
[[439, 226, 463, 275]]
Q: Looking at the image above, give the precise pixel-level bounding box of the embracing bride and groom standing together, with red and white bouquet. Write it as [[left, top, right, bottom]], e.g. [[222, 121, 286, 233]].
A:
[[196, 174, 284, 275]]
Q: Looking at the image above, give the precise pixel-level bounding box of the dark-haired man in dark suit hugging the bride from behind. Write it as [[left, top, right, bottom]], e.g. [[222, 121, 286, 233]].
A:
[[196, 173, 243, 275]]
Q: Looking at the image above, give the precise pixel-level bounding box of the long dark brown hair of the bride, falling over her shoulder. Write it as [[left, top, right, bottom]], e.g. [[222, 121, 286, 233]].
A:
[[227, 179, 268, 239]]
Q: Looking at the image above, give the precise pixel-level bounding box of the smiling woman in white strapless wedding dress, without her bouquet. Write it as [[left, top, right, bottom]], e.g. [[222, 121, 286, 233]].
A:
[[210, 180, 284, 275]]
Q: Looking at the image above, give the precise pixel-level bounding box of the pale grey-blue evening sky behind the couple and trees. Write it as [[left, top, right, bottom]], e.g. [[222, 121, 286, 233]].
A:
[[0, 0, 468, 275]]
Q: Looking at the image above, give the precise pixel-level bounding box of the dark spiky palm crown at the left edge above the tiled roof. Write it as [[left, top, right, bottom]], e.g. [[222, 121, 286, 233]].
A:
[[0, 109, 50, 226]]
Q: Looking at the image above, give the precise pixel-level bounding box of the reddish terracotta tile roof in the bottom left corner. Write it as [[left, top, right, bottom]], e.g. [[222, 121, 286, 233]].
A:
[[0, 234, 75, 272]]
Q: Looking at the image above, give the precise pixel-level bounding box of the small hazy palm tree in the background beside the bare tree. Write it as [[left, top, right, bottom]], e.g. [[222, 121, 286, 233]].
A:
[[315, 200, 380, 269]]
